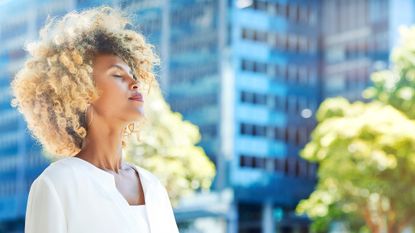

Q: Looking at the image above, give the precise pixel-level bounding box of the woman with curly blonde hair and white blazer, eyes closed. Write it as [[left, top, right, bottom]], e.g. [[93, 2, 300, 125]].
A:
[[12, 7, 178, 233]]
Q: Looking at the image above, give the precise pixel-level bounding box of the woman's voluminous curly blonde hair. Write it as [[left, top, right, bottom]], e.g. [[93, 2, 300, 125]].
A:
[[11, 7, 159, 156]]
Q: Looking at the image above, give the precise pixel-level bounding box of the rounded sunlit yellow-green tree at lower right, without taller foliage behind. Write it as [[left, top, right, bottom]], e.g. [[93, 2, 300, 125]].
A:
[[298, 98, 415, 232]]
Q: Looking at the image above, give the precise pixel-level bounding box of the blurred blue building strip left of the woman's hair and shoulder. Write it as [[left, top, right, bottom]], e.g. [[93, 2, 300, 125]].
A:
[[0, 1, 77, 232]]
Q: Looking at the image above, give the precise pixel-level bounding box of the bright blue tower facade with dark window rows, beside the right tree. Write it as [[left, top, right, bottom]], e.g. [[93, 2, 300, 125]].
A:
[[229, 0, 321, 232]]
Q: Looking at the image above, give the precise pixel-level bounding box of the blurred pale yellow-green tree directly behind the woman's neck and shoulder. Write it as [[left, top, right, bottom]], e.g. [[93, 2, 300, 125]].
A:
[[125, 87, 215, 205]]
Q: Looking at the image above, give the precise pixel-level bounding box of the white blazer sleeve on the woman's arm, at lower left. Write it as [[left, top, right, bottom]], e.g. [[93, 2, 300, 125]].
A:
[[25, 177, 67, 233]]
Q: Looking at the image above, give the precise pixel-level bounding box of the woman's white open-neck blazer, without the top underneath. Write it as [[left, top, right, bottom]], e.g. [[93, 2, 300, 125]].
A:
[[25, 157, 179, 233]]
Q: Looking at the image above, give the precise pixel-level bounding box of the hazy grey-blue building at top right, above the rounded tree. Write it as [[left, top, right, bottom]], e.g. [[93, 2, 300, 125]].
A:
[[321, 0, 415, 101]]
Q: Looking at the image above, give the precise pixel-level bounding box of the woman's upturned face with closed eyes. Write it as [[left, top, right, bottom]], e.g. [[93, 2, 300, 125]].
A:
[[93, 54, 144, 124]]
